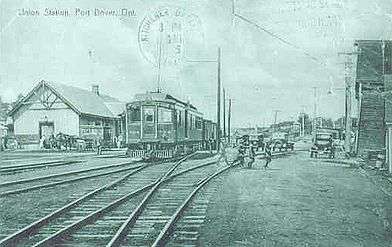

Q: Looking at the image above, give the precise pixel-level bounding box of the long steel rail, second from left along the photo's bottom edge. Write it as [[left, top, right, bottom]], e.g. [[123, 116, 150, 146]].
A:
[[33, 161, 216, 247]]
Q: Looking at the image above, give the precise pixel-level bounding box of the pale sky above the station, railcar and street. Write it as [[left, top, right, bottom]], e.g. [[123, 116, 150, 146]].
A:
[[0, 0, 392, 127]]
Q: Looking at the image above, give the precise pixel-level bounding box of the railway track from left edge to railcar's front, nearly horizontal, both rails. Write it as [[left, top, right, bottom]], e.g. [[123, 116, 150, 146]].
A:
[[0, 161, 144, 197]]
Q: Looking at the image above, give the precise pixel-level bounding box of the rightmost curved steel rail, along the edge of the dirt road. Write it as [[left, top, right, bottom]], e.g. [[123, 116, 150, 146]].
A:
[[151, 166, 233, 247]]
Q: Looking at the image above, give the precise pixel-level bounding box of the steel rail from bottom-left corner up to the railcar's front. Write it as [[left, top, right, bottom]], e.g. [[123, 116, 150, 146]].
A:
[[0, 164, 148, 246]]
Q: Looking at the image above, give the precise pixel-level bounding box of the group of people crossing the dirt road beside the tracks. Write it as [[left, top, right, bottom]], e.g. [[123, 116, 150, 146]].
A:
[[218, 139, 272, 169]]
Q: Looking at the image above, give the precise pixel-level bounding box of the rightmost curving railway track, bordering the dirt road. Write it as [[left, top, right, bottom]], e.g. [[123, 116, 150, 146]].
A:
[[106, 159, 230, 247]]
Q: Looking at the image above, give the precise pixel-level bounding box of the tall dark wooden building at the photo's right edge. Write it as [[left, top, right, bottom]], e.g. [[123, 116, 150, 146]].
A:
[[355, 40, 392, 156]]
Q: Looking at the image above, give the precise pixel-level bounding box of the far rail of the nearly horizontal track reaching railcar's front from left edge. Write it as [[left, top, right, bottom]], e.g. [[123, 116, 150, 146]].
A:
[[0, 162, 137, 188]]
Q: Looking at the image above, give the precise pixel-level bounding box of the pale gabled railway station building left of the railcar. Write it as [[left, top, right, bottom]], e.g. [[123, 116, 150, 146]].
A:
[[9, 81, 125, 146]]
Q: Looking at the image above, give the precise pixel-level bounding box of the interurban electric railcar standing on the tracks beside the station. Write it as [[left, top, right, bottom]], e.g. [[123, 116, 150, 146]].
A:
[[125, 92, 216, 158]]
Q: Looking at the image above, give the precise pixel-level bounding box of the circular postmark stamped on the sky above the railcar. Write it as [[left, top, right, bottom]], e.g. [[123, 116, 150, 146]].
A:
[[138, 6, 201, 67]]
